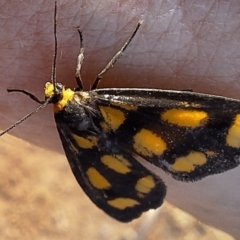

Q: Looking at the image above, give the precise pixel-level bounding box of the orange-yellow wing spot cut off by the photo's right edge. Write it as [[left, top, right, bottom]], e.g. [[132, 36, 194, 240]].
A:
[[226, 114, 240, 148]]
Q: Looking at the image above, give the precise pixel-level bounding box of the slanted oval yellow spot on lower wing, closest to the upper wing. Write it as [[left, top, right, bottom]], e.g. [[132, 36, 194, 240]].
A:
[[101, 155, 131, 174]]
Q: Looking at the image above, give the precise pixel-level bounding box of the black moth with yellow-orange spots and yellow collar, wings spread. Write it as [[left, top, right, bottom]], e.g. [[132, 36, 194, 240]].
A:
[[0, 2, 240, 222]]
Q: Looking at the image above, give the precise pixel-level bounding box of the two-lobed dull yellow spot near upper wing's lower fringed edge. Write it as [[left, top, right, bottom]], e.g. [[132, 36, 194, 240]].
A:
[[172, 152, 207, 173]]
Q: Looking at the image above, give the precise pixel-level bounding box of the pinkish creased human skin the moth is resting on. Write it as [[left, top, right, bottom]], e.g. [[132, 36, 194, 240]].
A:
[[0, 0, 240, 237]]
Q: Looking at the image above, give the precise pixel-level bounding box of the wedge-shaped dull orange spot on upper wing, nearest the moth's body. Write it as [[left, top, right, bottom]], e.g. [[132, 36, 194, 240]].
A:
[[100, 106, 126, 131]]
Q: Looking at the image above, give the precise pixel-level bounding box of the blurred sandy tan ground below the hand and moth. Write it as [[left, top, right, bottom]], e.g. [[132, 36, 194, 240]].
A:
[[0, 135, 233, 240]]
